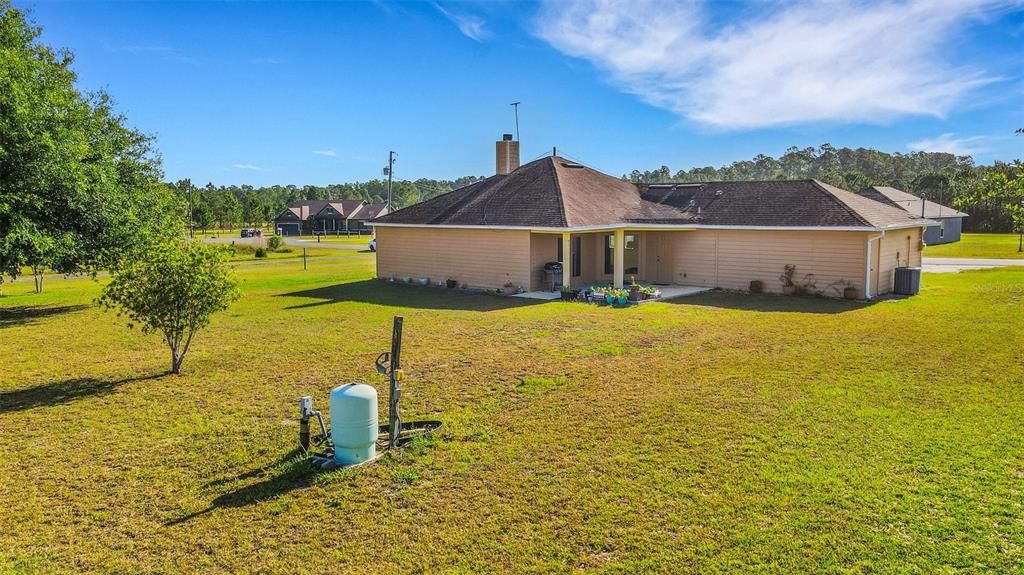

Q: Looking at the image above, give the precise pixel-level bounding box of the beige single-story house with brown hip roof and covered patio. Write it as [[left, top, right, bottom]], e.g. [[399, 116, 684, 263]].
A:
[[372, 142, 933, 298]]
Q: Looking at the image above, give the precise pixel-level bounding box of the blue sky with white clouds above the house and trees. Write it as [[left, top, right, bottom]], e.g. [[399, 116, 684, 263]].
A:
[[15, 0, 1024, 185]]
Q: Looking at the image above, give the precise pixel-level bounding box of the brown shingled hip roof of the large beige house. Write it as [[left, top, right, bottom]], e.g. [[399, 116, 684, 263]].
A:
[[375, 157, 925, 228]]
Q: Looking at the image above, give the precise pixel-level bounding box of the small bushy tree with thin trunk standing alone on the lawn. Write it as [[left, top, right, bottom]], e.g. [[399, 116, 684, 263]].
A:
[[99, 239, 239, 373]]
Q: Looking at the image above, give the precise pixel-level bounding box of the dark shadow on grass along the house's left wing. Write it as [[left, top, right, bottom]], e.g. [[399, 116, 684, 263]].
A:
[[281, 279, 544, 311]]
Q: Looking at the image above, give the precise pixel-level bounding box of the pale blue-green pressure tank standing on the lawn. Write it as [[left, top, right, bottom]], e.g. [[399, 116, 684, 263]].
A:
[[331, 383, 377, 466]]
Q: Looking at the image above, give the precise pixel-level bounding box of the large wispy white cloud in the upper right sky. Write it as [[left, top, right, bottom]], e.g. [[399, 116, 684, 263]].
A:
[[537, 0, 1006, 129]]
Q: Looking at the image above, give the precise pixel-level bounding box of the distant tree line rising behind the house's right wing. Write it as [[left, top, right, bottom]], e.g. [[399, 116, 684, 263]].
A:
[[623, 144, 1019, 232]]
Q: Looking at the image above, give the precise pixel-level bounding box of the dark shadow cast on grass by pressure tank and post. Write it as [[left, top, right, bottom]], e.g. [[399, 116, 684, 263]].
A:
[[165, 447, 323, 526]]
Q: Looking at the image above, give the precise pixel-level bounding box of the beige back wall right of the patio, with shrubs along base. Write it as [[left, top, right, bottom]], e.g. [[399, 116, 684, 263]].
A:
[[668, 229, 867, 297]]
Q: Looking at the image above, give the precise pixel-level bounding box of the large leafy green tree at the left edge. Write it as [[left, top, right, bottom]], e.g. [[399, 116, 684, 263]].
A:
[[0, 0, 183, 290]]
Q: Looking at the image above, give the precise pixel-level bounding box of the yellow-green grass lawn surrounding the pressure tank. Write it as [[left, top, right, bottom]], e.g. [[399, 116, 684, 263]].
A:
[[0, 253, 1024, 574]]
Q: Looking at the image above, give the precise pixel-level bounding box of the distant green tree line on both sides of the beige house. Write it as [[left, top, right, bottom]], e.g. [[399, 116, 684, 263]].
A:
[[174, 144, 1018, 232]]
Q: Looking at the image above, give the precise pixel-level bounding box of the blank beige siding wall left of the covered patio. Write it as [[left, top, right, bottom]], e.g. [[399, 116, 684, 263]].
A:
[[376, 227, 530, 289]]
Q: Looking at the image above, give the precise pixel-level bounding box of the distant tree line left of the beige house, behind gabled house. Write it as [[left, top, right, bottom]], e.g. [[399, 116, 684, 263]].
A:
[[167, 176, 483, 229]]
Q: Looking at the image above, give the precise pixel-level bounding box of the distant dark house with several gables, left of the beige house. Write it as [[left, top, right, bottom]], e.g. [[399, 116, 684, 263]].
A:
[[273, 200, 388, 235]]
